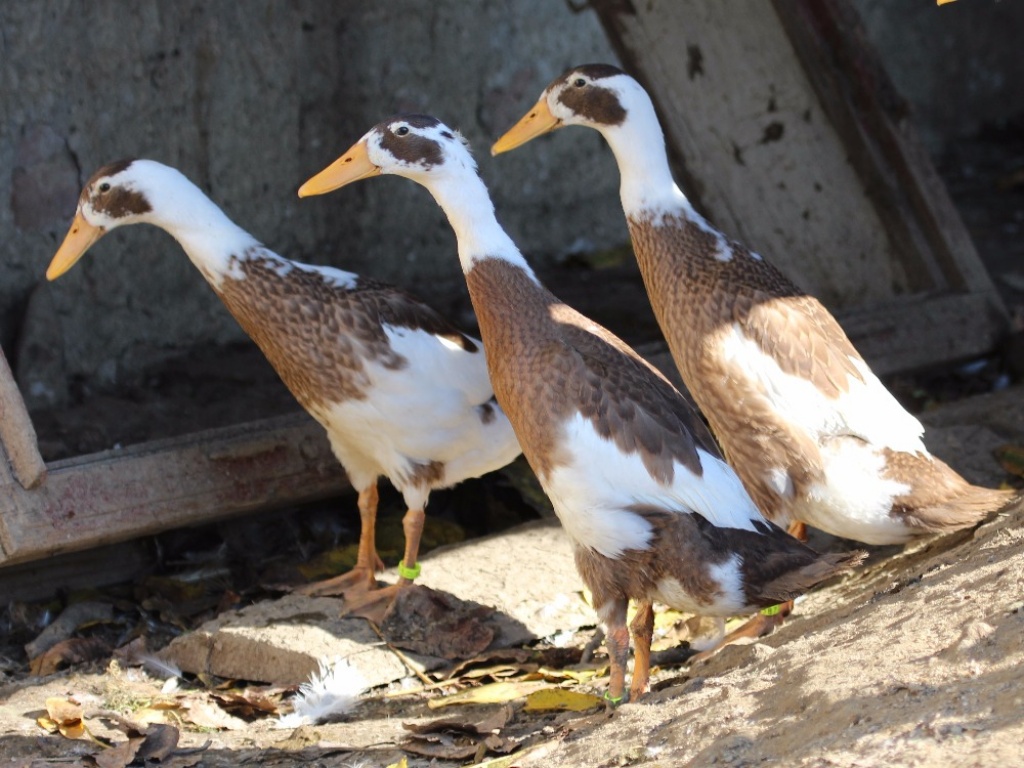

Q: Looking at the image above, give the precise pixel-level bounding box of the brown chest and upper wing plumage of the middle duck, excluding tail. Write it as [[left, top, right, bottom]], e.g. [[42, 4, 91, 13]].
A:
[[466, 259, 719, 482]]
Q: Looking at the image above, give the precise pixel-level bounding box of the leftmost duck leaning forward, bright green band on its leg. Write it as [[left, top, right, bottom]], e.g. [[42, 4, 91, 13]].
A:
[[46, 159, 520, 620]]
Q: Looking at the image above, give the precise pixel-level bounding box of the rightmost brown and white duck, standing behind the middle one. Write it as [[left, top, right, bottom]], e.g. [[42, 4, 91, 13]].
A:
[[493, 65, 1012, 557]]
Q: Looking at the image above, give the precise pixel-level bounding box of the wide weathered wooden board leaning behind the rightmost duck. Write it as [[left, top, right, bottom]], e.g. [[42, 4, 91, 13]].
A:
[[591, 0, 1007, 371]]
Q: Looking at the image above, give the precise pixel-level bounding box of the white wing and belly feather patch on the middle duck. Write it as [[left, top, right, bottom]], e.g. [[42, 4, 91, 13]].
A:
[[541, 414, 764, 557]]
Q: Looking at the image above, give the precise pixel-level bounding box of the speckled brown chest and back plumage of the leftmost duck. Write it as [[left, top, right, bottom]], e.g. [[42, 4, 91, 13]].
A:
[[212, 250, 484, 418]]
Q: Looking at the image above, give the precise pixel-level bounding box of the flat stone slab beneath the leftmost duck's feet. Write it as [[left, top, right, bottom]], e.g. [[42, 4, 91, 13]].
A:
[[161, 521, 597, 686]]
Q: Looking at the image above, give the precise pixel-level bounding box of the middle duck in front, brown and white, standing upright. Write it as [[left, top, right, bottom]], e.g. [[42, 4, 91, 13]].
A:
[[299, 115, 863, 702]]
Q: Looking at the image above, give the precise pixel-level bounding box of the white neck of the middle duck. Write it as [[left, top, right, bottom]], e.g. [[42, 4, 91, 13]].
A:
[[429, 172, 537, 282]]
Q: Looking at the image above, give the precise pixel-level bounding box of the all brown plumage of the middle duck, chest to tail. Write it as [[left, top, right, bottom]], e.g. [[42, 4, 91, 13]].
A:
[[466, 259, 860, 607]]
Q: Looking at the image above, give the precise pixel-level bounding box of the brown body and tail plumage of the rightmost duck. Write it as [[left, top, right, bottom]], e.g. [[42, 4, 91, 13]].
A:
[[628, 217, 1012, 531]]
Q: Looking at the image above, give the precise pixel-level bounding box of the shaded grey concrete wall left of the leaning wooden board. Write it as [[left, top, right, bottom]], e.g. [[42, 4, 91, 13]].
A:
[[0, 0, 628, 407]]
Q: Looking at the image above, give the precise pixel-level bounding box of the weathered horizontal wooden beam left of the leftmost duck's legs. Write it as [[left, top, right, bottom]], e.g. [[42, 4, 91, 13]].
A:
[[0, 413, 350, 565]]
